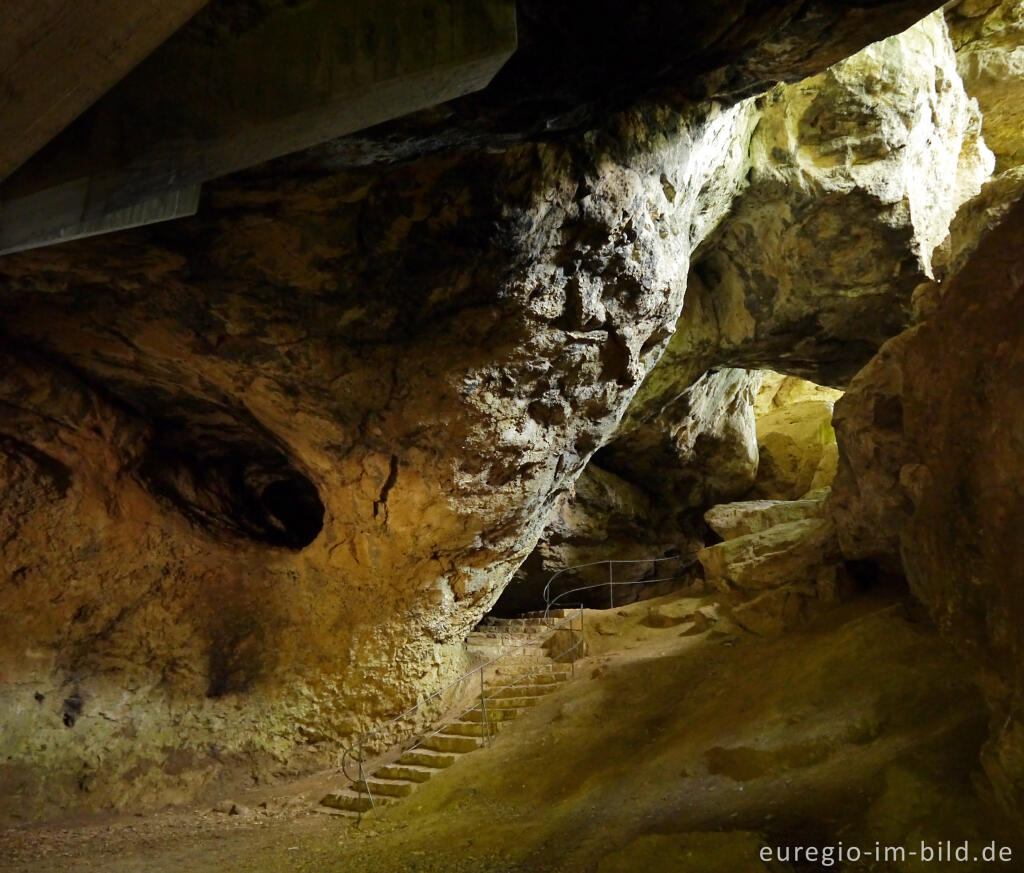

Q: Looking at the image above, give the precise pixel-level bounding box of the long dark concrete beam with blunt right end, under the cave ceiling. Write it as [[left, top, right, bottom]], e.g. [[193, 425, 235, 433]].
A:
[[0, 0, 516, 251]]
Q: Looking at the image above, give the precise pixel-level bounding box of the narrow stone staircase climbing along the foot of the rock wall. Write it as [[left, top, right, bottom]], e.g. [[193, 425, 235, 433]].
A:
[[321, 610, 579, 818]]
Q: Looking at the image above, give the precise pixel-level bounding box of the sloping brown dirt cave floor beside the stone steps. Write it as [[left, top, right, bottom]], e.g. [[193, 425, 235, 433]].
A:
[[0, 595, 1024, 873]]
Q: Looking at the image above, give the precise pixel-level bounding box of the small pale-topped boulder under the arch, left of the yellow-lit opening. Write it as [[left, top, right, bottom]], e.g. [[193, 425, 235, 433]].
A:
[[599, 368, 761, 510]]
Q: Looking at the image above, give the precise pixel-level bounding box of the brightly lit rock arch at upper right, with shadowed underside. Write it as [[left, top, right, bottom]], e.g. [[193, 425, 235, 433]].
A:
[[624, 10, 993, 433]]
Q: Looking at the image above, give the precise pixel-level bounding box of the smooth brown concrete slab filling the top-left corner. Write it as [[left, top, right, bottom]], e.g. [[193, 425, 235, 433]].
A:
[[0, 0, 206, 180]]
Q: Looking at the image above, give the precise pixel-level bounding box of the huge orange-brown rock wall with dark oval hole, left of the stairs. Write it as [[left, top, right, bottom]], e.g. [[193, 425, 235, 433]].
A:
[[0, 100, 750, 807]]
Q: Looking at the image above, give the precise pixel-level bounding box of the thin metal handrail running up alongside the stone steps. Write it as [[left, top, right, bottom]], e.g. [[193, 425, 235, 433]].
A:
[[341, 606, 584, 817]]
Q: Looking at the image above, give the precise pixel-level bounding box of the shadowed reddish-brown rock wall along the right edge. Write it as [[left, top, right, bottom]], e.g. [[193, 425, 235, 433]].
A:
[[834, 194, 1024, 815]]
